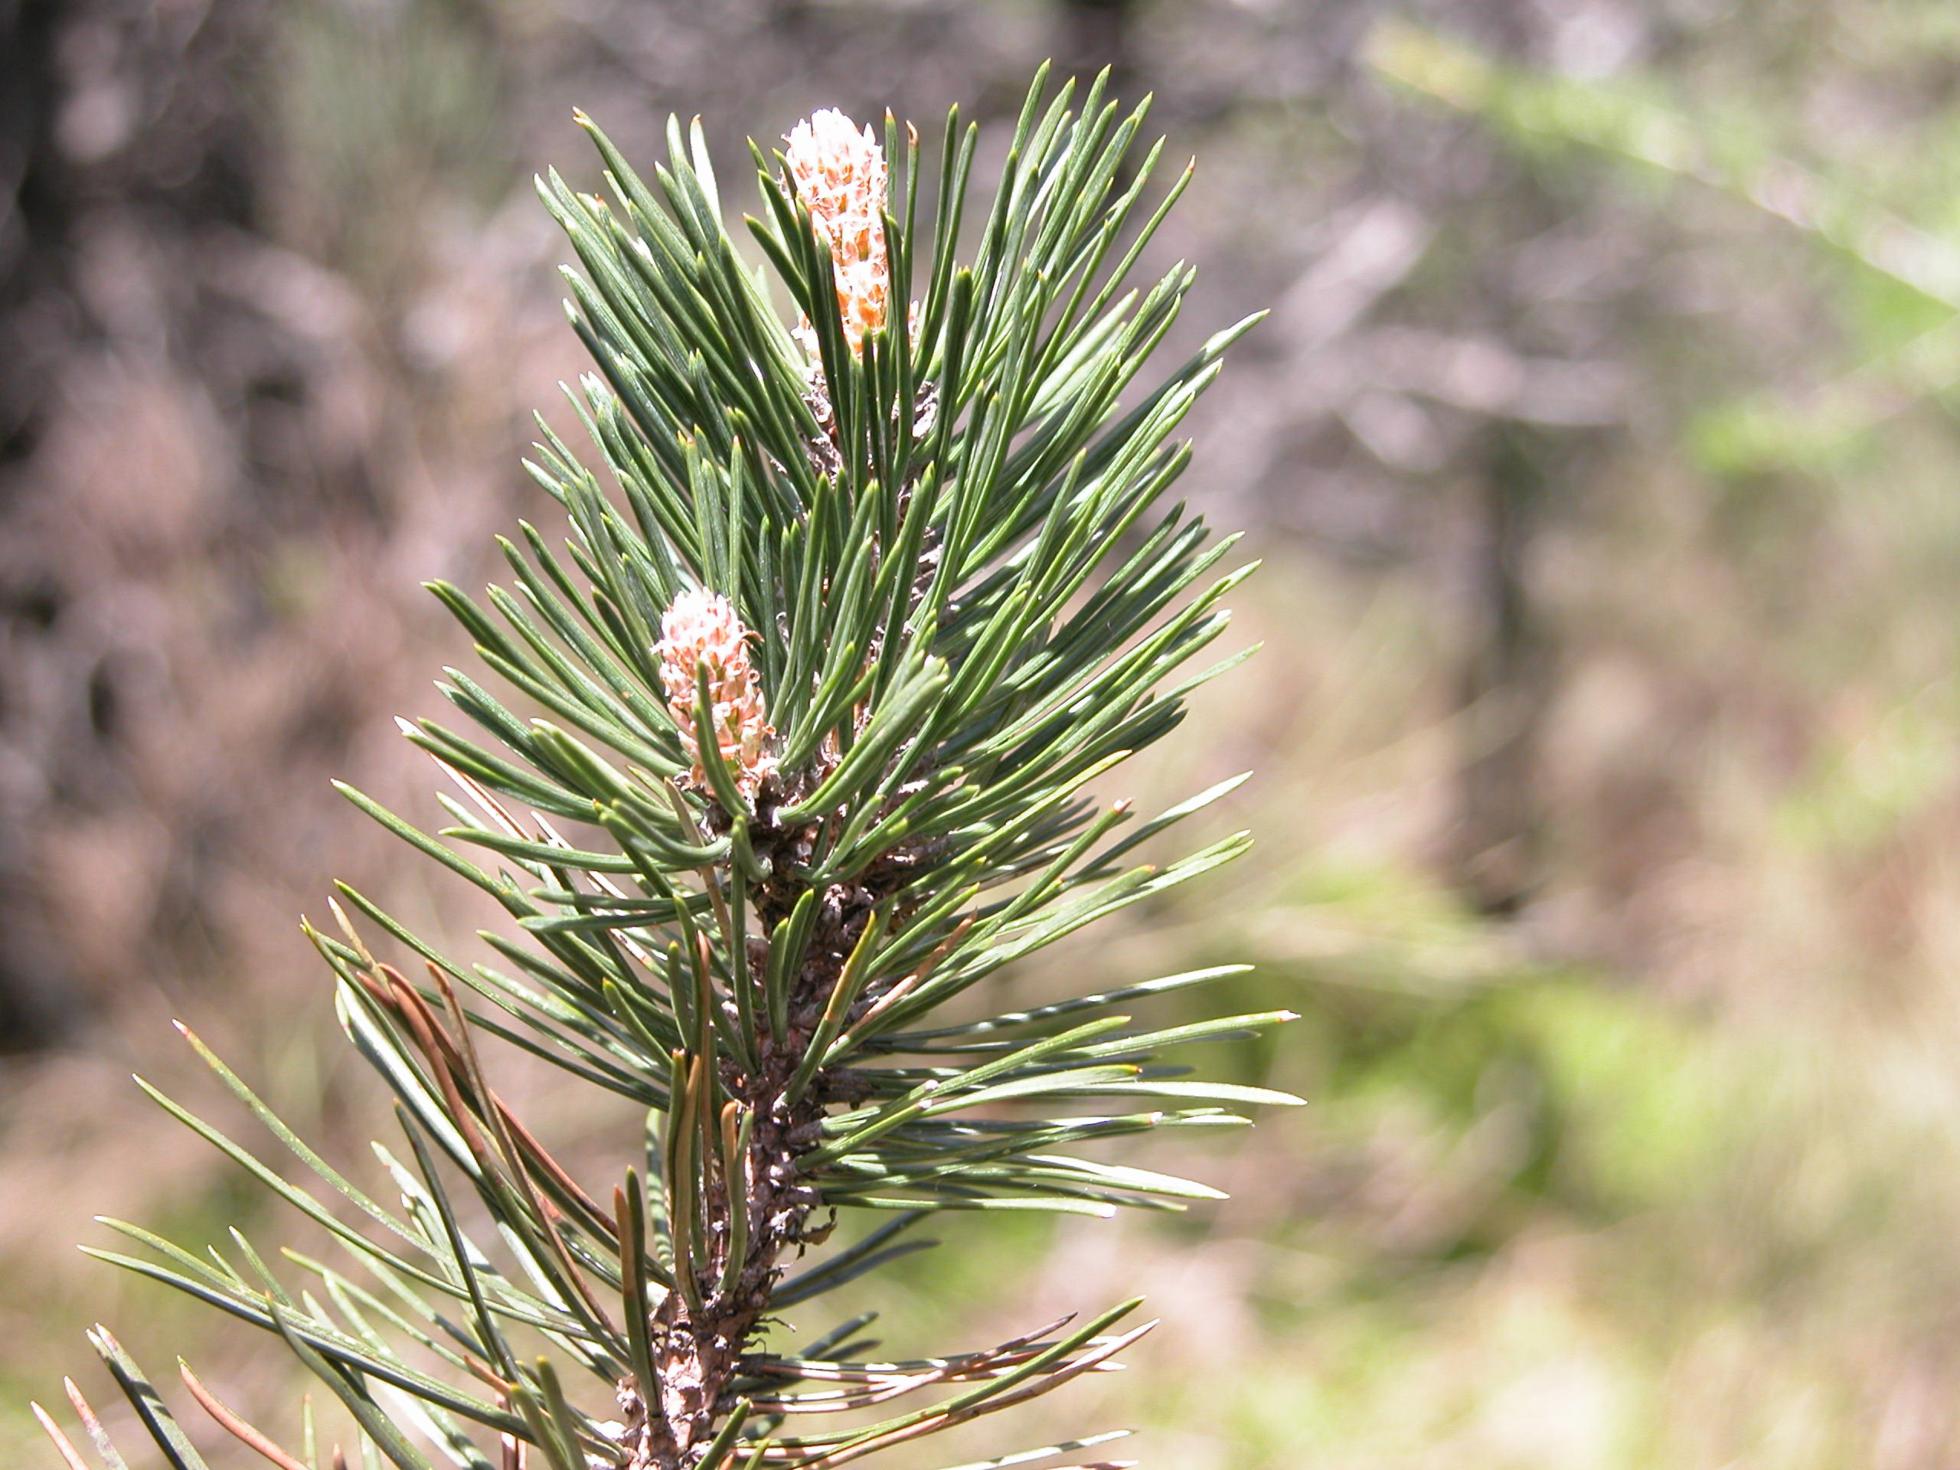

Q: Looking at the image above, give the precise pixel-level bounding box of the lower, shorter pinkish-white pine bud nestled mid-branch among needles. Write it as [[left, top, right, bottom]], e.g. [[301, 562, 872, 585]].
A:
[[655, 588, 776, 798]]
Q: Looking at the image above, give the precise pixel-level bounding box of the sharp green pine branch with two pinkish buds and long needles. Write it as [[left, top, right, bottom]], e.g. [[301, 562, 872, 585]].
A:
[[37, 74, 1292, 1470]]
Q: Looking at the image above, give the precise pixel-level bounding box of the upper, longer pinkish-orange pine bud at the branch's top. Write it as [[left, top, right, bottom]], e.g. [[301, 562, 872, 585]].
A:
[[782, 108, 892, 359]]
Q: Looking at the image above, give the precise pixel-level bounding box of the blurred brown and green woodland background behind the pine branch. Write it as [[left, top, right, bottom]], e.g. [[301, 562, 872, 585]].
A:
[[11, 0, 1960, 1470]]
